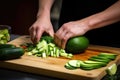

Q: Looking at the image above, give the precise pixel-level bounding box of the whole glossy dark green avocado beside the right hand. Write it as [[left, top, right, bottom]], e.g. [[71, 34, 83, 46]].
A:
[[65, 36, 89, 54]]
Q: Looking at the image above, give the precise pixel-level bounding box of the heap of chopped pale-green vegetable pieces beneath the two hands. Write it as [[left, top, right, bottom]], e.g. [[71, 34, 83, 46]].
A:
[[21, 36, 73, 58]]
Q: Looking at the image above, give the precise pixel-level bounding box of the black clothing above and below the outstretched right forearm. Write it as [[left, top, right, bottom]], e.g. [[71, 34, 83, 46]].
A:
[[59, 0, 120, 47]]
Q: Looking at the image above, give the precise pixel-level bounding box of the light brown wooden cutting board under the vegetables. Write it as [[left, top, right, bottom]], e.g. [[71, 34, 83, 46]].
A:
[[0, 35, 120, 80]]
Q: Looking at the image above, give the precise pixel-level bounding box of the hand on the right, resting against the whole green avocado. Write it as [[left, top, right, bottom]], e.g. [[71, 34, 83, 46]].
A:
[[54, 20, 89, 49]]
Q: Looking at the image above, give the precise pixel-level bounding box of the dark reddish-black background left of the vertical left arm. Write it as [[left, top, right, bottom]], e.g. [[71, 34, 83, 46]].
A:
[[0, 0, 38, 35]]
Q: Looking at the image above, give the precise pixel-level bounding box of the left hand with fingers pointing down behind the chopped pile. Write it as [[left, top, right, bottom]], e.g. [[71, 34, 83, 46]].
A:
[[29, 16, 54, 43]]
